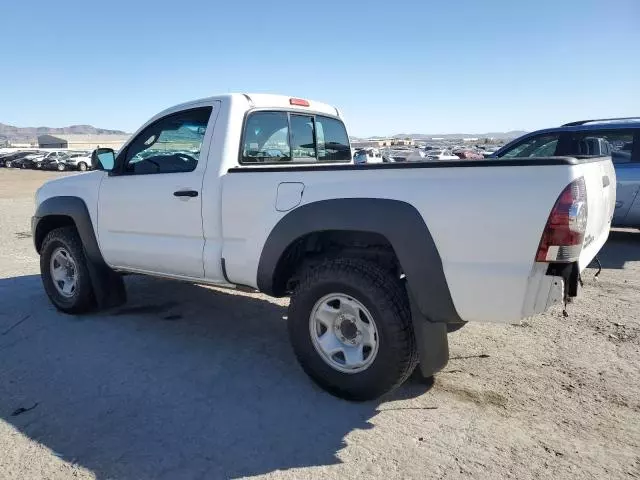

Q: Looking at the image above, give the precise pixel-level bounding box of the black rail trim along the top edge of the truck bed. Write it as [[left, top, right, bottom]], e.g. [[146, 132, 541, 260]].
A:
[[227, 156, 610, 173]]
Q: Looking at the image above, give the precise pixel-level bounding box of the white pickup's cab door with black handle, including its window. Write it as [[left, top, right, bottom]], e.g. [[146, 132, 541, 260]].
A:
[[98, 105, 215, 278]]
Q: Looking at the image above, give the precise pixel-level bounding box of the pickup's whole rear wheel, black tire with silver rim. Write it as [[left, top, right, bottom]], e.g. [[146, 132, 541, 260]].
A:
[[288, 259, 418, 401]]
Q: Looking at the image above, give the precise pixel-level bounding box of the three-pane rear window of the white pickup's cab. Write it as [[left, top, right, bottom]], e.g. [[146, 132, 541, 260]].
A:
[[240, 111, 351, 164]]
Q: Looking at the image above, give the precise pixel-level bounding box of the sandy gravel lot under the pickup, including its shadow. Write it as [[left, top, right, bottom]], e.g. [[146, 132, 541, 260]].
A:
[[0, 169, 640, 479]]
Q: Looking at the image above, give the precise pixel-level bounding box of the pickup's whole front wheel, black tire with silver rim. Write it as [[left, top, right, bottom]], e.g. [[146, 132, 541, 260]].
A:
[[40, 227, 95, 313]]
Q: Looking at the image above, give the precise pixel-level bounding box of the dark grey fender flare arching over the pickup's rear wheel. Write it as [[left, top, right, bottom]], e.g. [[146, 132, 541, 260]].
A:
[[257, 198, 463, 323]]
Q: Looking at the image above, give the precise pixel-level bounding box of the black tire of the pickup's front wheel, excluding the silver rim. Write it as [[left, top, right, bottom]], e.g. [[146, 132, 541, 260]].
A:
[[40, 227, 96, 314]]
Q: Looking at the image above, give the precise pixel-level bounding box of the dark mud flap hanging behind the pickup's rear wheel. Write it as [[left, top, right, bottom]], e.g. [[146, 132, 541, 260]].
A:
[[407, 289, 449, 378]]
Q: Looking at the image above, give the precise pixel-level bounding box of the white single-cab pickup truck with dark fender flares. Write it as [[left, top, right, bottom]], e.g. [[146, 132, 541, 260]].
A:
[[32, 94, 616, 400]]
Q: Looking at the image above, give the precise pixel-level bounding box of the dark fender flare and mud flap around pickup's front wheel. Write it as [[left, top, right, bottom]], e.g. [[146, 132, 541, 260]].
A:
[[31, 196, 127, 308]]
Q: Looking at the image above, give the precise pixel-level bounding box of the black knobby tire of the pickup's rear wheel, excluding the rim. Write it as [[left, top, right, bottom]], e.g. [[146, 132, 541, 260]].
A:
[[288, 258, 418, 401]]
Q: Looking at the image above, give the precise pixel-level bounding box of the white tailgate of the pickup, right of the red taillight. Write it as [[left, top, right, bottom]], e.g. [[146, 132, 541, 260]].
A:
[[576, 157, 616, 271]]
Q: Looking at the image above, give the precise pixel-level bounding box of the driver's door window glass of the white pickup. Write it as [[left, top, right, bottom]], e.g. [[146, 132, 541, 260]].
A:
[[124, 107, 212, 175]]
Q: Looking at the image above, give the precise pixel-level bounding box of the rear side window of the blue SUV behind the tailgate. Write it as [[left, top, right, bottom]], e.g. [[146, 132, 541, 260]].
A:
[[566, 130, 634, 163]]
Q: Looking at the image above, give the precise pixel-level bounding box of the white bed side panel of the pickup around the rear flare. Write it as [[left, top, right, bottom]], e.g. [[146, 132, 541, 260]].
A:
[[222, 165, 578, 322]]
